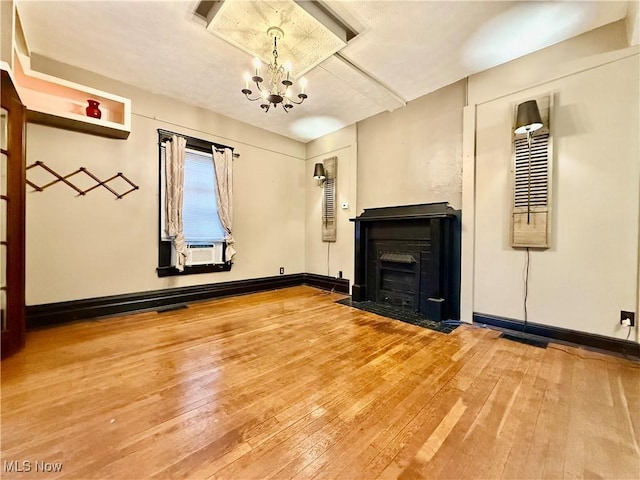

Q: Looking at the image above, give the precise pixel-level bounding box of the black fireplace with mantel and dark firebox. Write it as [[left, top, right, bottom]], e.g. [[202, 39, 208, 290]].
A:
[[351, 202, 461, 321]]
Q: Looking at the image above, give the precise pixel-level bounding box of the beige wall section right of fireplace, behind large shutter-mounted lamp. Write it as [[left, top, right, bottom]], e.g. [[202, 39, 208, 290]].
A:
[[463, 23, 640, 340]]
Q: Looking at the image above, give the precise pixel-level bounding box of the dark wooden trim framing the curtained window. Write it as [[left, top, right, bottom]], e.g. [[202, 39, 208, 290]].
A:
[[156, 128, 233, 277]]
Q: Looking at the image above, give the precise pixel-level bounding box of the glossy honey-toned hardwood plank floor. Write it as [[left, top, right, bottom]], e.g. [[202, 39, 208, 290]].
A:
[[1, 287, 640, 479]]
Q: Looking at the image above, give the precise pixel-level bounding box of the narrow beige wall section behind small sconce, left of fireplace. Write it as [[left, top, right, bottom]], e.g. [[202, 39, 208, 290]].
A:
[[304, 125, 358, 281]]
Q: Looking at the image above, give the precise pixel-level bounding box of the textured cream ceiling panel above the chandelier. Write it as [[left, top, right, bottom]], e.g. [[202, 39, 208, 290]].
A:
[[207, 0, 346, 77]]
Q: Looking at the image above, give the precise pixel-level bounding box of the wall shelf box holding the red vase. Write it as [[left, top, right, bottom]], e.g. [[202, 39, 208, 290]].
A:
[[14, 51, 131, 139]]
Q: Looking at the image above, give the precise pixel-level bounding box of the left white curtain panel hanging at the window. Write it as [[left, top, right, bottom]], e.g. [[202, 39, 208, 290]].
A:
[[165, 135, 187, 271]]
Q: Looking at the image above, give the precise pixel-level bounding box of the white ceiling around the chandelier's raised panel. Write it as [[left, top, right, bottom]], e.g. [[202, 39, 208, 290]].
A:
[[17, 0, 628, 142]]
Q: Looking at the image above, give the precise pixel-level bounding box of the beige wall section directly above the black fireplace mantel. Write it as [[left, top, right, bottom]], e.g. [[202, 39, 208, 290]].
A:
[[357, 81, 466, 214]]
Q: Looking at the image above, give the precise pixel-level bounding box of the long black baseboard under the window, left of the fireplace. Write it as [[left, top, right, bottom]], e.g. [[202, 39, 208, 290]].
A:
[[26, 273, 349, 328]]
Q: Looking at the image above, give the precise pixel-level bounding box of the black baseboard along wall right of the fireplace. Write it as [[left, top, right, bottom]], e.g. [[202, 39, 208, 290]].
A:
[[473, 312, 640, 358]]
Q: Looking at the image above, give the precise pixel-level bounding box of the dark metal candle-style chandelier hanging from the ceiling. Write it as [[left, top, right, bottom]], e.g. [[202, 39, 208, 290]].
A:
[[242, 27, 307, 113]]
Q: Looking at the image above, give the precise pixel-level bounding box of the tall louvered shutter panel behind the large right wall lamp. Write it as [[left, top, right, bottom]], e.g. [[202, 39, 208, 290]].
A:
[[511, 96, 552, 248]]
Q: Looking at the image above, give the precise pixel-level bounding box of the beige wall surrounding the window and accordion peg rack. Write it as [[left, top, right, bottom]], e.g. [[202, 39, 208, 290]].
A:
[[26, 58, 308, 305]]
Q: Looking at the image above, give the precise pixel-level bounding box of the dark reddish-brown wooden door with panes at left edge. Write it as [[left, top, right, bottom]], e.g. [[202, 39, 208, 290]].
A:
[[0, 70, 26, 358]]
